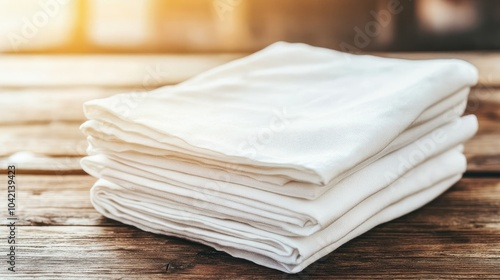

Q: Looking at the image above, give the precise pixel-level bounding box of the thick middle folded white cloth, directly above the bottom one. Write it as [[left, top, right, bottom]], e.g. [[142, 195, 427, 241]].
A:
[[82, 116, 477, 236]]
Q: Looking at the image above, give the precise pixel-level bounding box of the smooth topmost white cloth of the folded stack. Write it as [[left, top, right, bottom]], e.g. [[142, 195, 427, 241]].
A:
[[85, 42, 477, 185]]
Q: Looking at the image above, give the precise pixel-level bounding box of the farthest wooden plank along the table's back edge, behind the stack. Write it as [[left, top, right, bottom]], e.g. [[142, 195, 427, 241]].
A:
[[0, 52, 500, 88]]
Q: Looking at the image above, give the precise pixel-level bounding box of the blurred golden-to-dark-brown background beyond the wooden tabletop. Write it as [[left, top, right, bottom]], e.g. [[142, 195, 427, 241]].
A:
[[0, 0, 500, 54]]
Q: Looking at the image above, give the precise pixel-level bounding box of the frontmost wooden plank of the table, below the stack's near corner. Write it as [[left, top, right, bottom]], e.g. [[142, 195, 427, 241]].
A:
[[0, 226, 492, 279]]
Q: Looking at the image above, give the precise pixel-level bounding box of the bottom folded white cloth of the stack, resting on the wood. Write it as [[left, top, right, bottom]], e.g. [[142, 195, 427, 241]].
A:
[[91, 147, 466, 273]]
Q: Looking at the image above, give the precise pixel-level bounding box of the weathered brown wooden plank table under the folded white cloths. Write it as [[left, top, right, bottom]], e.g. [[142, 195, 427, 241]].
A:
[[0, 53, 500, 279]]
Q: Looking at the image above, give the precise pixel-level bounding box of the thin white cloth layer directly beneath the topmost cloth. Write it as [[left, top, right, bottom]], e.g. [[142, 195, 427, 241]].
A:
[[82, 89, 468, 199]]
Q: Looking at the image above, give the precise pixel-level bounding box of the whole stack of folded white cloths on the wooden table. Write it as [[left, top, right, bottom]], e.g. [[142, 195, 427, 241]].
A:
[[81, 42, 477, 273]]
